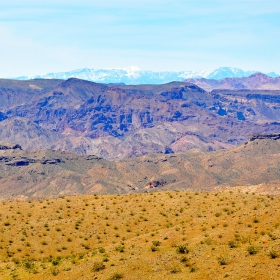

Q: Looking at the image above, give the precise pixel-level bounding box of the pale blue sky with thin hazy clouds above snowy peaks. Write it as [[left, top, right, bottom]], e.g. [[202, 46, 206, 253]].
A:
[[0, 0, 280, 77]]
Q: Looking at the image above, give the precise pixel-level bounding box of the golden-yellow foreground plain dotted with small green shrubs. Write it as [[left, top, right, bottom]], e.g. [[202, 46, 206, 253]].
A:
[[0, 191, 280, 280]]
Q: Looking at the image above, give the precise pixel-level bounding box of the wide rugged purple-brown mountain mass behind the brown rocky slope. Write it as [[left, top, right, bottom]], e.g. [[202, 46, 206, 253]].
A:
[[0, 79, 280, 159]]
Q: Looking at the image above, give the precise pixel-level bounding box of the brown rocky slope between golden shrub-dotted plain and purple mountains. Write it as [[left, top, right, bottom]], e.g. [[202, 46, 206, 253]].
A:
[[0, 135, 280, 198]]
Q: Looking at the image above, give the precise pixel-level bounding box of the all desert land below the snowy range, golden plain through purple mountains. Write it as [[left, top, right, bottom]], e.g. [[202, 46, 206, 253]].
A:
[[0, 73, 280, 280]]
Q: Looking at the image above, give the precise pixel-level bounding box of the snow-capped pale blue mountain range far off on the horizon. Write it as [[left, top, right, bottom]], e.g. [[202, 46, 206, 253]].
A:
[[14, 66, 279, 85]]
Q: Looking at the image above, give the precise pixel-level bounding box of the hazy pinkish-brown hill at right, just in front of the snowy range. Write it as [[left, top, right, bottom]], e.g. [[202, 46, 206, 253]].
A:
[[186, 73, 280, 91]]
